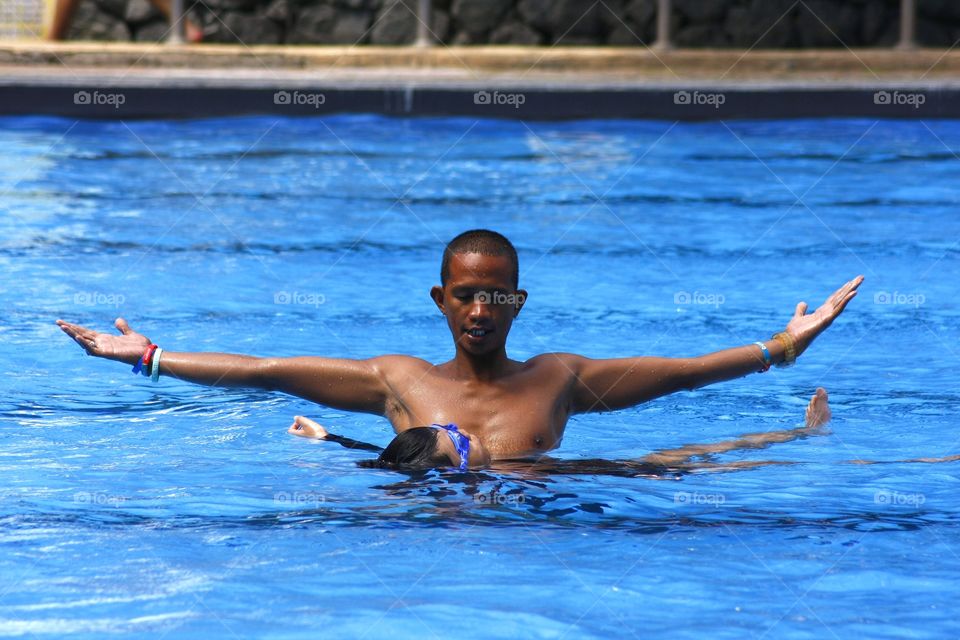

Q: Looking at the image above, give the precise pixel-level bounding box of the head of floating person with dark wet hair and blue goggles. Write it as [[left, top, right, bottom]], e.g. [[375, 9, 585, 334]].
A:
[[363, 425, 490, 470]]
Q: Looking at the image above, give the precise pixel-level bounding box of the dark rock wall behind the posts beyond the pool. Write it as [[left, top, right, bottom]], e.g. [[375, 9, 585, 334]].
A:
[[68, 0, 960, 48]]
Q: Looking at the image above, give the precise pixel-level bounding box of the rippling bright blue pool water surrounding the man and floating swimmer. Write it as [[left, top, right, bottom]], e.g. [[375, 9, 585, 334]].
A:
[[0, 116, 960, 638]]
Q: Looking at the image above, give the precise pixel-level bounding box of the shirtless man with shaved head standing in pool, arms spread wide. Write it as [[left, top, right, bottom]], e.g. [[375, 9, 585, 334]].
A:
[[57, 230, 863, 460]]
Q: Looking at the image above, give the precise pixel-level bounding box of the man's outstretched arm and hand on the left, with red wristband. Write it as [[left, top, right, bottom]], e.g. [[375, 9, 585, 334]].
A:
[[57, 318, 389, 415]]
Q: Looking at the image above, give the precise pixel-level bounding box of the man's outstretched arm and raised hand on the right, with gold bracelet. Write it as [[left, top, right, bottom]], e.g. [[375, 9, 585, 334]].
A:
[[562, 276, 863, 413]]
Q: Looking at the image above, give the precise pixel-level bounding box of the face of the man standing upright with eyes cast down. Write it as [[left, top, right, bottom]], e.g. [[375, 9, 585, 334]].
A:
[[430, 253, 527, 355]]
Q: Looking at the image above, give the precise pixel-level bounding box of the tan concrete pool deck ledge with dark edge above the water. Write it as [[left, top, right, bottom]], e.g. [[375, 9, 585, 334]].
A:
[[0, 42, 960, 120]]
